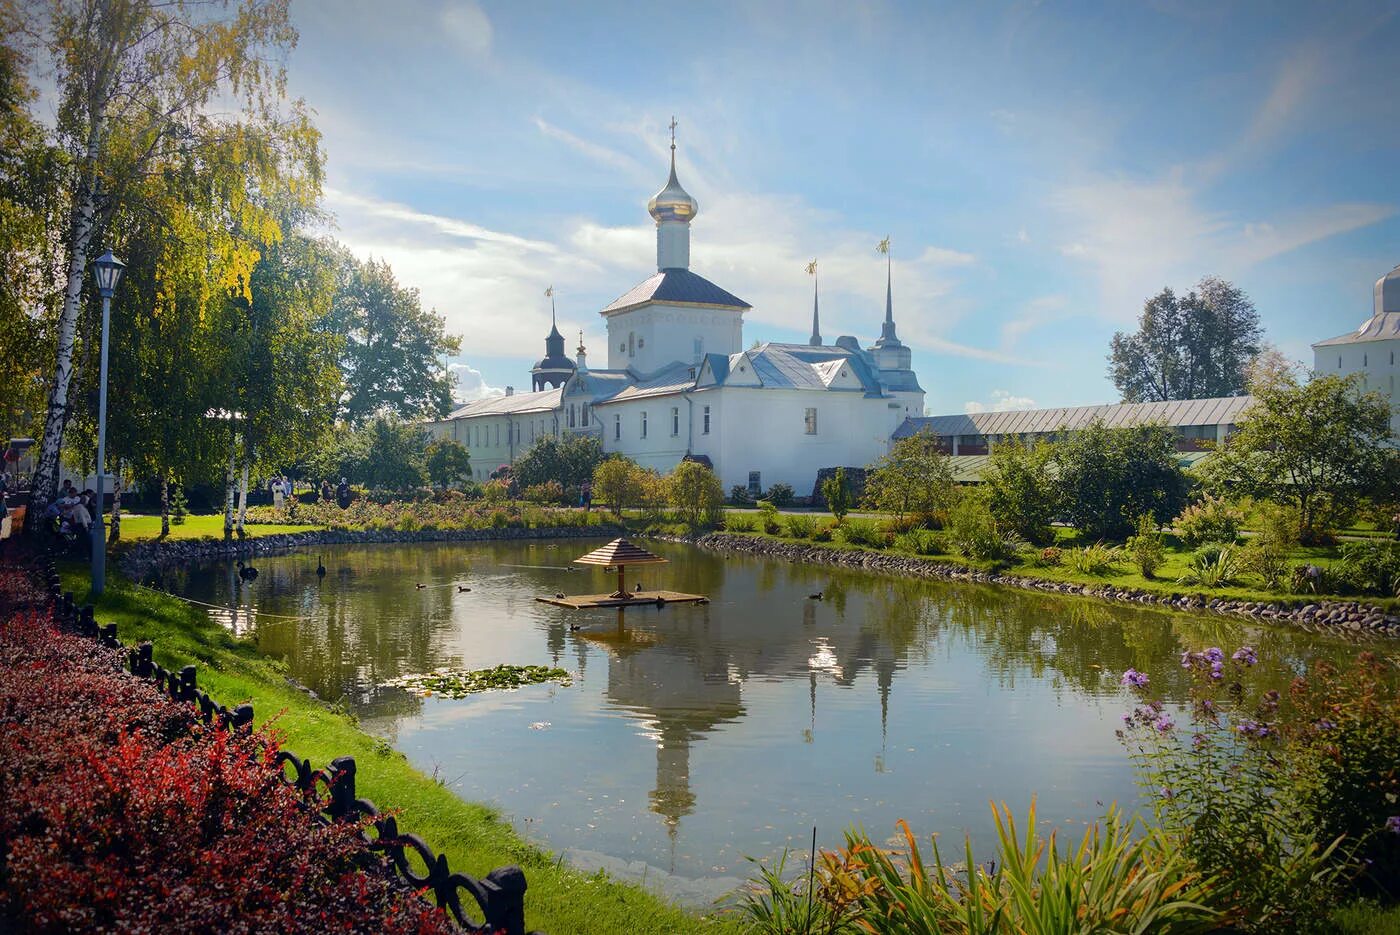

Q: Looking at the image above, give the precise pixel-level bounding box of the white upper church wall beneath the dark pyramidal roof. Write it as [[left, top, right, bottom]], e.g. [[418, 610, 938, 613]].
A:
[[608, 304, 743, 374]]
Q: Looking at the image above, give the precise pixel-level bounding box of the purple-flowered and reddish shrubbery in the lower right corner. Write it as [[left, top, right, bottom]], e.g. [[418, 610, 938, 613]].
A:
[[1119, 647, 1400, 932]]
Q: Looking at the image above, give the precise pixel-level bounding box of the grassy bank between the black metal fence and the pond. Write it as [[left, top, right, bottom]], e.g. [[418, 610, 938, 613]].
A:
[[64, 565, 741, 935]]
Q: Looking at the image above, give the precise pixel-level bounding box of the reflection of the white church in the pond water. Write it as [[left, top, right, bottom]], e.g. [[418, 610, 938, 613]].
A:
[[534, 563, 907, 841]]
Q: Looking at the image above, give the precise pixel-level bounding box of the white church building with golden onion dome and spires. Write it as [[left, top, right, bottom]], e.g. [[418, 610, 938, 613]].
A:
[[428, 141, 924, 495]]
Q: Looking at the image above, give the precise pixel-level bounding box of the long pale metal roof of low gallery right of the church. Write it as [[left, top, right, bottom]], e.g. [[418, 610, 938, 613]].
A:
[[895, 396, 1253, 438]]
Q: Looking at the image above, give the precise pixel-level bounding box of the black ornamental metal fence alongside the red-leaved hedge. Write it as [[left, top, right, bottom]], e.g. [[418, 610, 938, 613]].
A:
[[38, 564, 539, 935]]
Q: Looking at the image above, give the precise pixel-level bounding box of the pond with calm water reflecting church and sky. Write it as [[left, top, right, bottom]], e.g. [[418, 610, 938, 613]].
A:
[[150, 540, 1354, 903]]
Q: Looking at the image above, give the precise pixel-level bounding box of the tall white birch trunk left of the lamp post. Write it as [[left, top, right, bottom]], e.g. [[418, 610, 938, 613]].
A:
[[28, 116, 104, 529]]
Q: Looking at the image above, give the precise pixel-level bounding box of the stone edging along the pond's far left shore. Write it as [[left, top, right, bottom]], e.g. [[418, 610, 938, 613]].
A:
[[120, 525, 626, 581]]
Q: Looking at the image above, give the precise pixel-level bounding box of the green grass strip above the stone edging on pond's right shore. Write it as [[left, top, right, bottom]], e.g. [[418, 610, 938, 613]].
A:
[[711, 514, 1400, 612]]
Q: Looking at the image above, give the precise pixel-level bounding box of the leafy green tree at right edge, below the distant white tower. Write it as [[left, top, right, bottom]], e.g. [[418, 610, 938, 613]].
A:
[[1200, 374, 1400, 543]]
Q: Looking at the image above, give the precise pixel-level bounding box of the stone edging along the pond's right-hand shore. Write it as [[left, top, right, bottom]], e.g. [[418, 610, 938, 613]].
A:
[[687, 532, 1400, 637]]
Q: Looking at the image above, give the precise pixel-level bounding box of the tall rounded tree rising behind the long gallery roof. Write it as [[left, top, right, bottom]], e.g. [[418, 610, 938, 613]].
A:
[[1109, 276, 1263, 403]]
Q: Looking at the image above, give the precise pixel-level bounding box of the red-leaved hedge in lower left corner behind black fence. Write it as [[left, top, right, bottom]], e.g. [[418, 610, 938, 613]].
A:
[[0, 613, 451, 932]]
